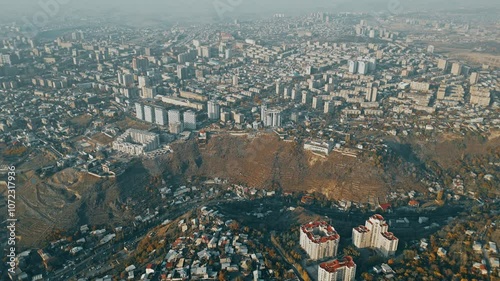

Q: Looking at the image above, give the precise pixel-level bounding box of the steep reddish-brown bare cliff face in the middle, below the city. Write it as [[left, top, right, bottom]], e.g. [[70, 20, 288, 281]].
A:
[[167, 135, 421, 202]]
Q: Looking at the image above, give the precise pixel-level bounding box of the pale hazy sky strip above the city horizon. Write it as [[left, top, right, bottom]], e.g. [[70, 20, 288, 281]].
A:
[[0, 0, 500, 23]]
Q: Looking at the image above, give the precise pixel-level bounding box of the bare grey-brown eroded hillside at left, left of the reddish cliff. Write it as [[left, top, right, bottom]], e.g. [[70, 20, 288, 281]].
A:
[[0, 163, 155, 249]]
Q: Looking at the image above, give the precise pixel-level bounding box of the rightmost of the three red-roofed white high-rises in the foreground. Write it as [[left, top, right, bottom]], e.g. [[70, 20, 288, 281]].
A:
[[352, 215, 399, 257]]
